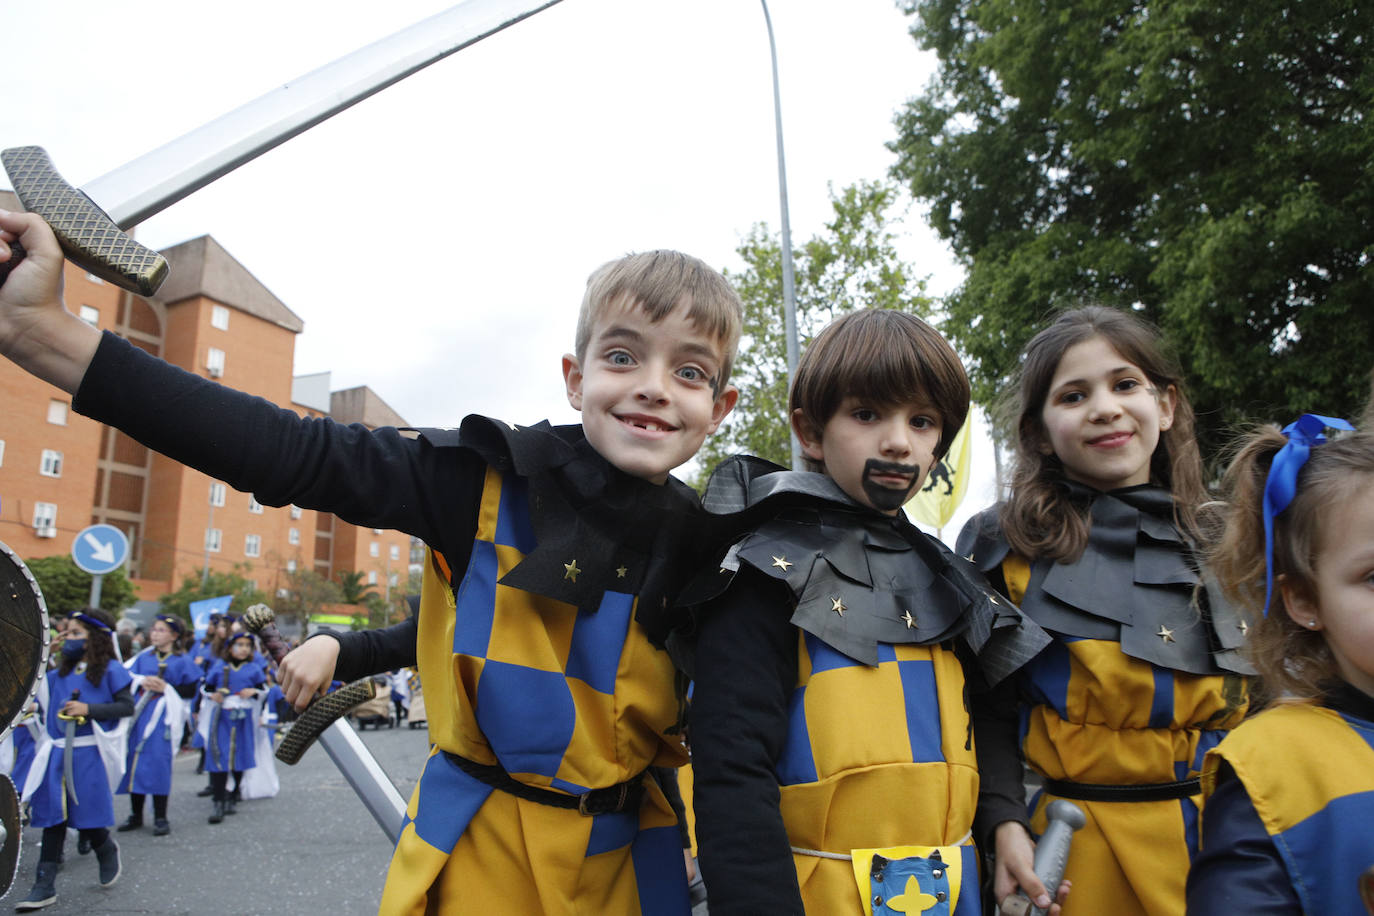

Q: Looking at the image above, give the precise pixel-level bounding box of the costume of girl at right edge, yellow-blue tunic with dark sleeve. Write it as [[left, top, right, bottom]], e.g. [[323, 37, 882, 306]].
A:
[[1189, 684, 1374, 916]]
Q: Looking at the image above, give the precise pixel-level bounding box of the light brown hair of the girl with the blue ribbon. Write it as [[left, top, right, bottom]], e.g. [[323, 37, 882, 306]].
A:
[[1208, 426, 1374, 699]]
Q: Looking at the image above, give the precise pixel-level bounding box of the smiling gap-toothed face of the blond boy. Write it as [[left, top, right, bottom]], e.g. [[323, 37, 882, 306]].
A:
[[563, 302, 739, 483]]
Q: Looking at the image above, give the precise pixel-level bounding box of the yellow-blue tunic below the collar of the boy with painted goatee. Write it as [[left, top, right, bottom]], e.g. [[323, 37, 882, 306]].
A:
[[776, 630, 980, 916]]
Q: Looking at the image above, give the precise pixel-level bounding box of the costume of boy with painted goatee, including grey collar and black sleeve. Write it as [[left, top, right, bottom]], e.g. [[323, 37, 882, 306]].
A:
[[677, 460, 1047, 916]]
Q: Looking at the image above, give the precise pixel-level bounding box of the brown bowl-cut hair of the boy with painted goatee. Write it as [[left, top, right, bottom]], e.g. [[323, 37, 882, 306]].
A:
[[787, 309, 969, 471]]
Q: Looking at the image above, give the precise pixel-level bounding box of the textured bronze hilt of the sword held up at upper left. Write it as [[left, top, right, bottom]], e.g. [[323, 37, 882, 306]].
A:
[[0, 147, 169, 295]]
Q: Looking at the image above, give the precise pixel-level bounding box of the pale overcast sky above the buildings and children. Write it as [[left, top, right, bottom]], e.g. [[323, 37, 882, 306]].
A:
[[0, 0, 991, 538]]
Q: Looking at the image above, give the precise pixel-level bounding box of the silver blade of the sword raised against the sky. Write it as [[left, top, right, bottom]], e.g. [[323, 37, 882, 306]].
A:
[[81, 0, 559, 229]]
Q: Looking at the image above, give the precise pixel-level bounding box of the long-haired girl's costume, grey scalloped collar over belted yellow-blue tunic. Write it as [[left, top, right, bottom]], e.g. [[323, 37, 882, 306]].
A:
[[958, 483, 1252, 916]]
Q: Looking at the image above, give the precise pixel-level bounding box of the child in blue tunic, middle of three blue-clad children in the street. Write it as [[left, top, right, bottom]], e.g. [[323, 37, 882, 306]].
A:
[[115, 614, 201, 836]]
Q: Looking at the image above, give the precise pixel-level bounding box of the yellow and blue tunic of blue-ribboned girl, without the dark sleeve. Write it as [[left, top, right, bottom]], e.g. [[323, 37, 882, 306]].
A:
[[1202, 705, 1374, 916]]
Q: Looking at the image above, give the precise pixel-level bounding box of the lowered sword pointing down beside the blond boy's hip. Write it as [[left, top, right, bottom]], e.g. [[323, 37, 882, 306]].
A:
[[243, 604, 405, 842]]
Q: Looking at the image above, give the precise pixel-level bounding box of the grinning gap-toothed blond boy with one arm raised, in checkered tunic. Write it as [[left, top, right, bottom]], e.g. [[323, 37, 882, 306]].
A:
[[0, 213, 741, 913]]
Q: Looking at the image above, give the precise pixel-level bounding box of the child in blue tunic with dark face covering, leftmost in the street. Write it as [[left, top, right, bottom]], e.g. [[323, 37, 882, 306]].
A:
[[15, 608, 133, 912]]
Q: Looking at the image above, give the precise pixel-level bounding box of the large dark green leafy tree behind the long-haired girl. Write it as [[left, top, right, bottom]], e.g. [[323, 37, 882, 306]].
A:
[[890, 0, 1374, 453]]
